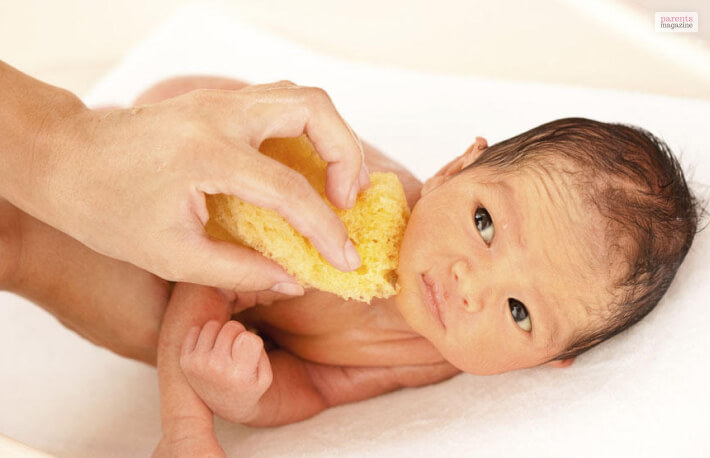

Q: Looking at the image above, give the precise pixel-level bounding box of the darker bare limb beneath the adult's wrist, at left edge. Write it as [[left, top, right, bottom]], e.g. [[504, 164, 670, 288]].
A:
[[5, 199, 170, 364]]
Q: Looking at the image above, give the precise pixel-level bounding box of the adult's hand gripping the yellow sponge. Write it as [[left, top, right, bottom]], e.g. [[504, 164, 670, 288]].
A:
[[0, 66, 369, 293]]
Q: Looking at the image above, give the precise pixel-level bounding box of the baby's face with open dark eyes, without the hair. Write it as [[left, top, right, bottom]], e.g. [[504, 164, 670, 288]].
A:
[[397, 141, 610, 375]]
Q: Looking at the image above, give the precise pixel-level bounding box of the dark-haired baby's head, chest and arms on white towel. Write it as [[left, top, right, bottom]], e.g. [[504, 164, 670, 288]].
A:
[[145, 80, 697, 456]]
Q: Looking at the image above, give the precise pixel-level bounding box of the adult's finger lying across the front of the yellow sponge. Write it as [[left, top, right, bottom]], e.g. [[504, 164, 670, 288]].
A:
[[201, 145, 361, 274]]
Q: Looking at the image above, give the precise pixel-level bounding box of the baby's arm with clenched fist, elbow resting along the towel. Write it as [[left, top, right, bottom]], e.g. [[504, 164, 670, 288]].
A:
[[178, 309, 459, 426]]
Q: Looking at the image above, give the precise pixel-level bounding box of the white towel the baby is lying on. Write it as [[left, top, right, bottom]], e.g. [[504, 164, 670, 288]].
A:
[[0, 7, 710, 457]]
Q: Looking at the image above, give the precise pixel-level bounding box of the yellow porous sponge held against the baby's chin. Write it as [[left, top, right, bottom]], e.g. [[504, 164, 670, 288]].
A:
[[205, 135, 409, 302]]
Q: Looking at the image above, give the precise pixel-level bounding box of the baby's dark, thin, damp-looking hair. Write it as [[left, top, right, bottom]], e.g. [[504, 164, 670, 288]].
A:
[[467, 118, 699, 361]]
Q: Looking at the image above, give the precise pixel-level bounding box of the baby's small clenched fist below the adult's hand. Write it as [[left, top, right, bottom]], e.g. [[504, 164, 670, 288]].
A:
[[180, 321, 272, 423]]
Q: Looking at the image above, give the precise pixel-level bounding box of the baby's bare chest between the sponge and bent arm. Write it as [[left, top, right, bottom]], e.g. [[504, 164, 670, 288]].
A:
[[242, 291, 444, 366]]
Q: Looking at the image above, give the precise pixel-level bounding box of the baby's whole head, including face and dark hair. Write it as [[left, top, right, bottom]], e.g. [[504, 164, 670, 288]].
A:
[[397, 118, 697, 374]]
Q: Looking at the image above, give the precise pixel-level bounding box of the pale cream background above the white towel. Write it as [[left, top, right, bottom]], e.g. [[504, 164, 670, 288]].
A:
[[0, 0, 710, 99]]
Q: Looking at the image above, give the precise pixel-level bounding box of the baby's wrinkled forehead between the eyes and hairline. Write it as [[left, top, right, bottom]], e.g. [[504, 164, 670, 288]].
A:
[[484, 167, 613, 303]]
